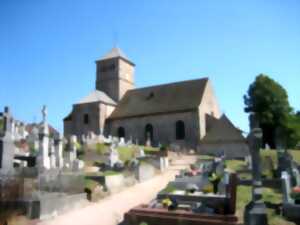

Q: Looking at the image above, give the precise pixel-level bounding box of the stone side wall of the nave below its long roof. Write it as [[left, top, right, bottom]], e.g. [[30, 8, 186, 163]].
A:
[[108, 110, 200, 147]]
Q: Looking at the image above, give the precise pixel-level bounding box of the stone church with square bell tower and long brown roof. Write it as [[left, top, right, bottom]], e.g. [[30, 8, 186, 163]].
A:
[[64, 48, 245, 156]]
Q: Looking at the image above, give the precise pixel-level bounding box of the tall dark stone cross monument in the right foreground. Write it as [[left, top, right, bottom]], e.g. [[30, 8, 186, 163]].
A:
[[244, 114, 268, 225]]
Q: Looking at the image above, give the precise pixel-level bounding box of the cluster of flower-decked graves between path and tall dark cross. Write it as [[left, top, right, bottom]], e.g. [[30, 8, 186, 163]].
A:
[[125, 158, 238, 225]]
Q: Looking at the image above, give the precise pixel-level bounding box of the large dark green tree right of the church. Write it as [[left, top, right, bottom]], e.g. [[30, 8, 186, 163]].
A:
[[244, 74, 292, 148]]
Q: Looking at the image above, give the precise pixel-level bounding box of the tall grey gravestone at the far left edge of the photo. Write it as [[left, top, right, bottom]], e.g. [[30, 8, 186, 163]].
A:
[[0, 107, 15, 174]]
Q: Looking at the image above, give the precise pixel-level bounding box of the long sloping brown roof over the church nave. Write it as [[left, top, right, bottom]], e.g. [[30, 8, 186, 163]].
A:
[[110, 78, 208, 119]]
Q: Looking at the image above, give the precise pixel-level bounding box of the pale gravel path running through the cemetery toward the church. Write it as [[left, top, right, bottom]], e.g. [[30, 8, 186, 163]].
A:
[[39, 156, 195, 225]]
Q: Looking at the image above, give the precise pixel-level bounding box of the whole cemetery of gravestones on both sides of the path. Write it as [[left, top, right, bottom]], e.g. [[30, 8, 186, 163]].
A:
[[0, 107, 300, 225]]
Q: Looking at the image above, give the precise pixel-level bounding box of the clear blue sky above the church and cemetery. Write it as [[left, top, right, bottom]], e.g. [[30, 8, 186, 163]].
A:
[[0, 0, 300, 131]]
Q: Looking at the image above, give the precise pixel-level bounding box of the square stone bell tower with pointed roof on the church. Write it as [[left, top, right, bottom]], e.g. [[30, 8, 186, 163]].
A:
[[96, 48, 135, 102]]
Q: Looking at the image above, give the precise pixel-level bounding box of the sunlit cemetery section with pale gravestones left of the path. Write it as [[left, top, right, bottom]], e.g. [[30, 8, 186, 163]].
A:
[[0, 107, 173, 222]]
